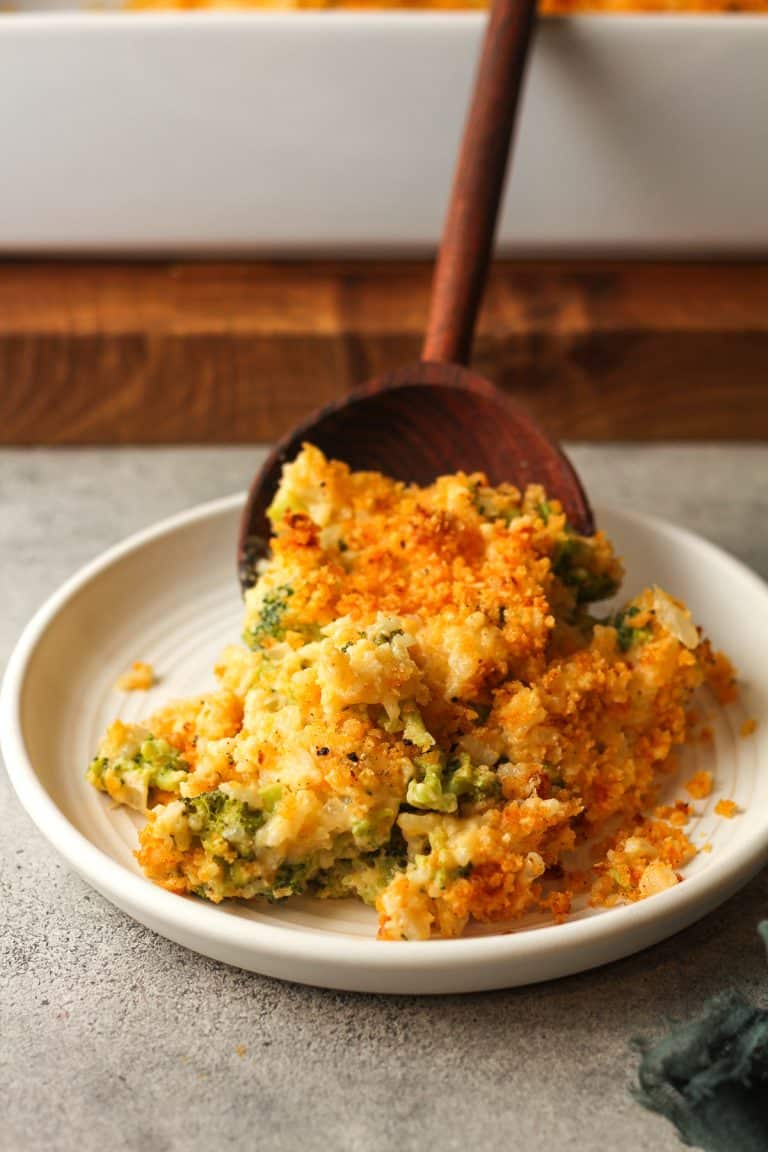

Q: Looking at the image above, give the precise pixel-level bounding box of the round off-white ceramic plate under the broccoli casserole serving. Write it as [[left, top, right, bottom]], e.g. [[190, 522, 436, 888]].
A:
[[1, 497, 768, 993]]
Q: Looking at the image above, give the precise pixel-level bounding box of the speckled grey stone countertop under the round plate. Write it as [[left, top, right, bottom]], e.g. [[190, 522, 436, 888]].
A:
[[0, 446, 768, 1152]]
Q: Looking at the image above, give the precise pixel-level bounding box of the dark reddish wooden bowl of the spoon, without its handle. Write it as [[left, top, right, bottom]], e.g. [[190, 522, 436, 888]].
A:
[[238, 363, 594, 592]]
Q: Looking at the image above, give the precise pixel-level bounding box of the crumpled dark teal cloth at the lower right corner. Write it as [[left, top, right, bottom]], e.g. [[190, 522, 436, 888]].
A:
[[633, 922, 768, 1152]]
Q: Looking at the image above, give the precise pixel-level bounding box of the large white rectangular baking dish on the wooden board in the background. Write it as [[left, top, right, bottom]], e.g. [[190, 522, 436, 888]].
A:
[[0, 10, 768, 255]]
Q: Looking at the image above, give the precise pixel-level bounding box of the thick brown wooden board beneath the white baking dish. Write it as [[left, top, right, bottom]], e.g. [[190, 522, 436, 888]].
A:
[[0, 260, 768, 445]]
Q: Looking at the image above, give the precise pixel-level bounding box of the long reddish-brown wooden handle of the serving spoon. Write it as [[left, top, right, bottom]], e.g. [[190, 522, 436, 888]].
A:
[[421, 0, 537, 364]]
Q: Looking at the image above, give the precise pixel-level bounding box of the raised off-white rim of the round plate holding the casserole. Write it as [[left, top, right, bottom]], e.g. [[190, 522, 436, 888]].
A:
[[0, 493, 768, 986]]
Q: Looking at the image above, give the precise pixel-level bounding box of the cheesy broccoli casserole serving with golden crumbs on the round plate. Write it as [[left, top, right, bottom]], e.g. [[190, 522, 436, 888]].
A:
[[88, 446, 735, 940]]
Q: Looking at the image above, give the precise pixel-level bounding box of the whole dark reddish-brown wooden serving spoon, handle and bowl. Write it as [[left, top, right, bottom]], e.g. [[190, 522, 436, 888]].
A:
[[238, 0, 594, 591]]
